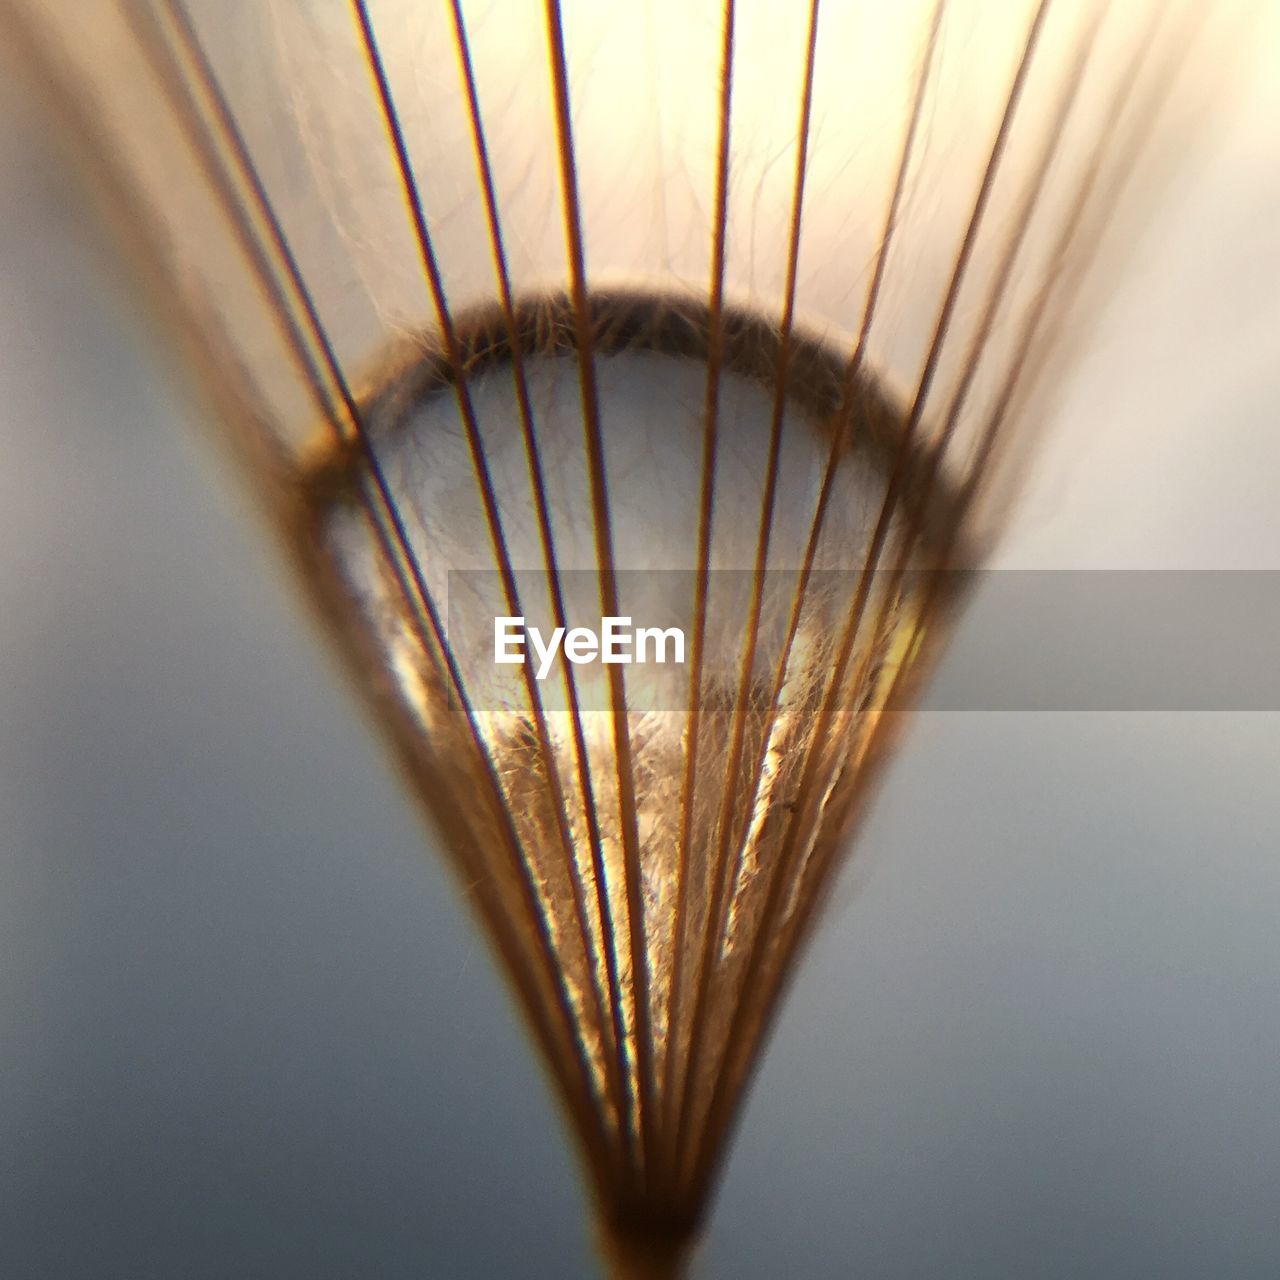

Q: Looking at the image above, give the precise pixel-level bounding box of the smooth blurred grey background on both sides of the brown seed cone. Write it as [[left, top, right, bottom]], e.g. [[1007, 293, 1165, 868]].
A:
[[0, 57, 1280, 1280]]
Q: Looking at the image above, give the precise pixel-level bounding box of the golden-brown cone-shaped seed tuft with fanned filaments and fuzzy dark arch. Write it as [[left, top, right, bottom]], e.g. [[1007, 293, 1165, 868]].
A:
[[0, 0, 1233, 1271]]
